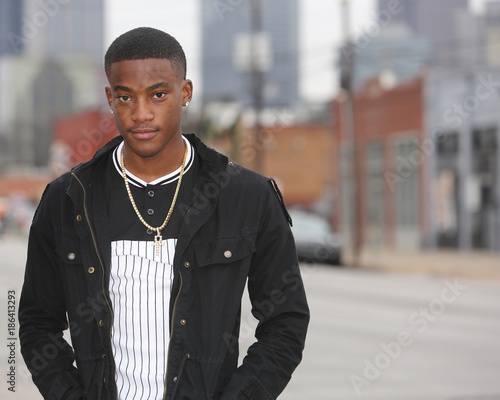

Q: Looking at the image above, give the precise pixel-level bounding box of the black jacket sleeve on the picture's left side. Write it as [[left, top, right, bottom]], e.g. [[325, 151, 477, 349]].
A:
[[19, 185, 84, 400]]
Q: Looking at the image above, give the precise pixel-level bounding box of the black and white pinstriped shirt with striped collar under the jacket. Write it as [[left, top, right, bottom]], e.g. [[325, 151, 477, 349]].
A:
[[109, 139, 194, 400]]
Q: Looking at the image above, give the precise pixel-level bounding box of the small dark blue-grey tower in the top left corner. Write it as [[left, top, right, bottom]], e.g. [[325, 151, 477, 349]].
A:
[[0, 0, 23, 56]]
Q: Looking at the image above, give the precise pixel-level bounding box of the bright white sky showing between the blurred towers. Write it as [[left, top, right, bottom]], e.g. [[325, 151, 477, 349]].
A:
[[104, 0, 489, 103]]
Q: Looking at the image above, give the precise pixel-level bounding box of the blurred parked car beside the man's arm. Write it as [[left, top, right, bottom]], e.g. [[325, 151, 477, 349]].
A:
[[289, 209, 341, 265]]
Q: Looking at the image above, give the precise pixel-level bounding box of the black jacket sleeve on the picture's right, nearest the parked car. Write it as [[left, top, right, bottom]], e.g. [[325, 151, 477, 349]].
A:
[[221, 180, 309, 400]]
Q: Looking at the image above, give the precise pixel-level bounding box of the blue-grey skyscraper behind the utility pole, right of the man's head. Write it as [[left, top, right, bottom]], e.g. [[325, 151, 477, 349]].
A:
[[201, 0, 299, 107]]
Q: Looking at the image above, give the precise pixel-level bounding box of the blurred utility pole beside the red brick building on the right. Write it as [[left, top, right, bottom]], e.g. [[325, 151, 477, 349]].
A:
[[341, 0, 362, 266]]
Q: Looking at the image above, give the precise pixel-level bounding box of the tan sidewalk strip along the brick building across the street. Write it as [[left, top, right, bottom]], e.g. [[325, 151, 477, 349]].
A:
[[343, 249, 500, 280]]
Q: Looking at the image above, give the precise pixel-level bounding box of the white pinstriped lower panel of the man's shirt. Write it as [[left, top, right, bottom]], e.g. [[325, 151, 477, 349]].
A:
[[110, 239, 176, 400]]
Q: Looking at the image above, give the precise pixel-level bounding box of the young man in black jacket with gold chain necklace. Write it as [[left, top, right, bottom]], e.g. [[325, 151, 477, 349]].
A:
[[19, 28, 309, 400]]
